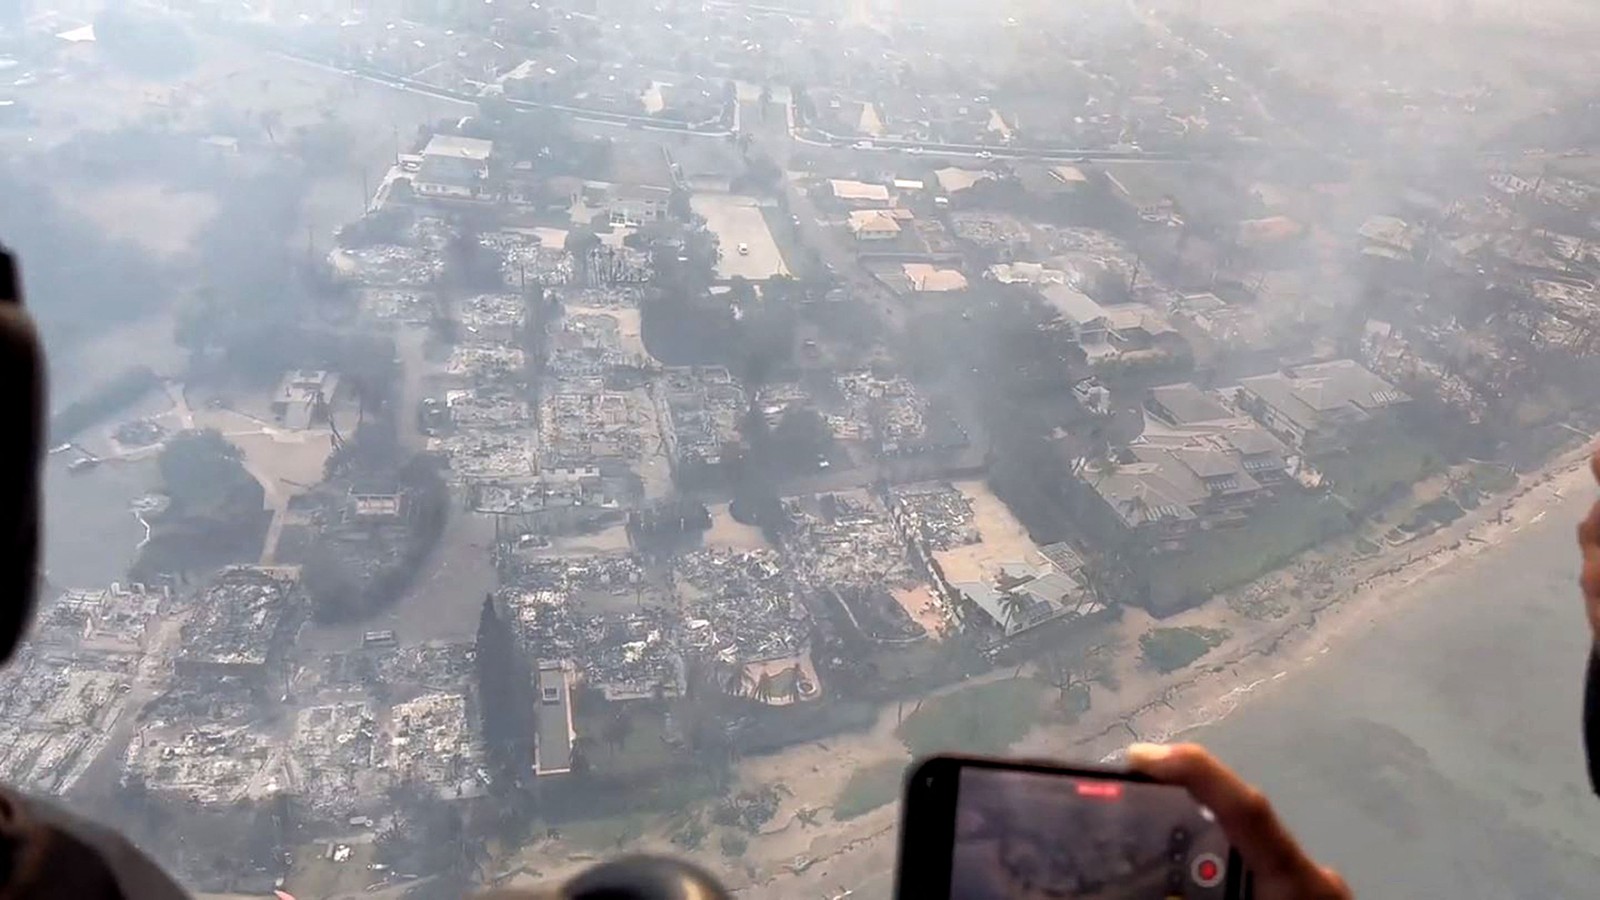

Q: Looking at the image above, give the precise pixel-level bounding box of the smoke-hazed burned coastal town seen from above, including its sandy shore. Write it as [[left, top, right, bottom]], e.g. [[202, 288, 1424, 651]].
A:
[[0, 0, 1600, 900]]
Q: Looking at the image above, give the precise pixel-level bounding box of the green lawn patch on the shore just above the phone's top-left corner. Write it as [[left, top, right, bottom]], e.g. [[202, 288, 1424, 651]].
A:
[[896, 679, 1042, 756]]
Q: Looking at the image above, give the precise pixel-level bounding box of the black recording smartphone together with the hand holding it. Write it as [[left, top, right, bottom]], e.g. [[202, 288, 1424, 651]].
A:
[[896, 745, 1350, 900]]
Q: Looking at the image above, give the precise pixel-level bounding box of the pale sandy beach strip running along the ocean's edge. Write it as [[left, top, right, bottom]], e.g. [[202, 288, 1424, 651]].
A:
[[733, 440, 1592, 900]]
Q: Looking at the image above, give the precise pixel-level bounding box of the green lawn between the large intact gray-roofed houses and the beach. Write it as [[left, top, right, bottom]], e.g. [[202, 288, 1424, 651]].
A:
[[1150, 493, 1350, 612]]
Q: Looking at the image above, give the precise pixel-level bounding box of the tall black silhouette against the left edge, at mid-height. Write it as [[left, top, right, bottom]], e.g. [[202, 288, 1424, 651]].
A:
[[0, 248, 45, 661]]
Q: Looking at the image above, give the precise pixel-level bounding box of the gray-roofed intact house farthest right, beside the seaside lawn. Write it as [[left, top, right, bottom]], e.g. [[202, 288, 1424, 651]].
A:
[[1237, 359, 1411, 455]]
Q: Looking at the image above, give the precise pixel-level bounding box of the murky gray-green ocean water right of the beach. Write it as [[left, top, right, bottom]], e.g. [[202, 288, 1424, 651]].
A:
[[1189, 492, 1600, 900]]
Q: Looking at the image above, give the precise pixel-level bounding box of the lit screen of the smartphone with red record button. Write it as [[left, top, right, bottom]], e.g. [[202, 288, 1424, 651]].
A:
[[950, 755, 1229, 900]]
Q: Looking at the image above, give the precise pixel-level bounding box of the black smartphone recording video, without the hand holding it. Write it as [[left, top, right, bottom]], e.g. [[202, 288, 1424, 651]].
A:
[[894, 756, 1248, 900]]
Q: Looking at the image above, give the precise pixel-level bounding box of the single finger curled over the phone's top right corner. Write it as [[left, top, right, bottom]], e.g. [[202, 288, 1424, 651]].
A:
[[1128, 743, 1312, 878]]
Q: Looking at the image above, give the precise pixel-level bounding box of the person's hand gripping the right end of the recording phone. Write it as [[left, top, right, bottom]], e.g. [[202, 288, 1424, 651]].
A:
[[1128, 743, 1354, 900]]
